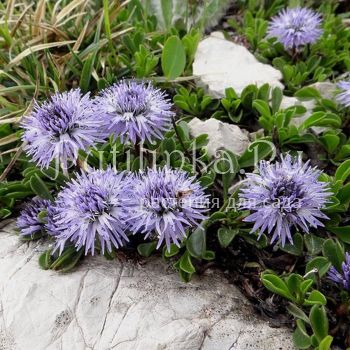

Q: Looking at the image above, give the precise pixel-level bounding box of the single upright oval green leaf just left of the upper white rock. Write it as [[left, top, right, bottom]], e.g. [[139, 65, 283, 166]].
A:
[[162, 35, 186, 80]]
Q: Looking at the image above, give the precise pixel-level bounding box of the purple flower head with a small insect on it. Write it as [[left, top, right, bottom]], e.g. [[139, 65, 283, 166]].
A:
[[126, 167, 209, 250]]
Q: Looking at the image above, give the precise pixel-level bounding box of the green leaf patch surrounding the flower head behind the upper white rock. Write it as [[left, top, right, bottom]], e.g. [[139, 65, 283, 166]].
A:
[[228, 0, 350, 94]]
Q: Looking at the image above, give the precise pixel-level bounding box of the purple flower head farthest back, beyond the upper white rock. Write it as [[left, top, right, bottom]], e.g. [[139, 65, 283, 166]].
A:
[[268, 7, 322, 49]]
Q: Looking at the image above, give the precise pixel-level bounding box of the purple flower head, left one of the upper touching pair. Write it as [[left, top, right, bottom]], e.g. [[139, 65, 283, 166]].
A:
[[22, 89, 107, 169]]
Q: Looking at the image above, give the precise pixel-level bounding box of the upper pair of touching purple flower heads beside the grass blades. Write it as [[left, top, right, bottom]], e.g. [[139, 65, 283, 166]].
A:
[[22, 81, 173, 169]]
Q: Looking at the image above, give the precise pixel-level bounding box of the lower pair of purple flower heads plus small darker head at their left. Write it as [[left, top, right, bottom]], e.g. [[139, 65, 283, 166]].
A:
[[18, 168, 209, 255]]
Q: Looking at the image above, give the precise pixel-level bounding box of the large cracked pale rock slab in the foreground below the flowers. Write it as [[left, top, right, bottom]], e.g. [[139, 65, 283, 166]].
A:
[[0, 221, 293, 350]]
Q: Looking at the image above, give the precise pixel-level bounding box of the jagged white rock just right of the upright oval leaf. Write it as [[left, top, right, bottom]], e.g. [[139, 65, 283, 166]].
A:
[[193, 32, 284, 98]]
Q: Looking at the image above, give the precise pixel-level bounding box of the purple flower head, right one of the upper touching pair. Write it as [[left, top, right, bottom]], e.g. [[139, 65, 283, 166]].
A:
[[96, 81, 174, 144]]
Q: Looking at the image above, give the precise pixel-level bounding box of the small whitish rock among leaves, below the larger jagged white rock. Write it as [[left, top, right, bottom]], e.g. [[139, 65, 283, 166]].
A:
[[188, 118, 249, 157]]
